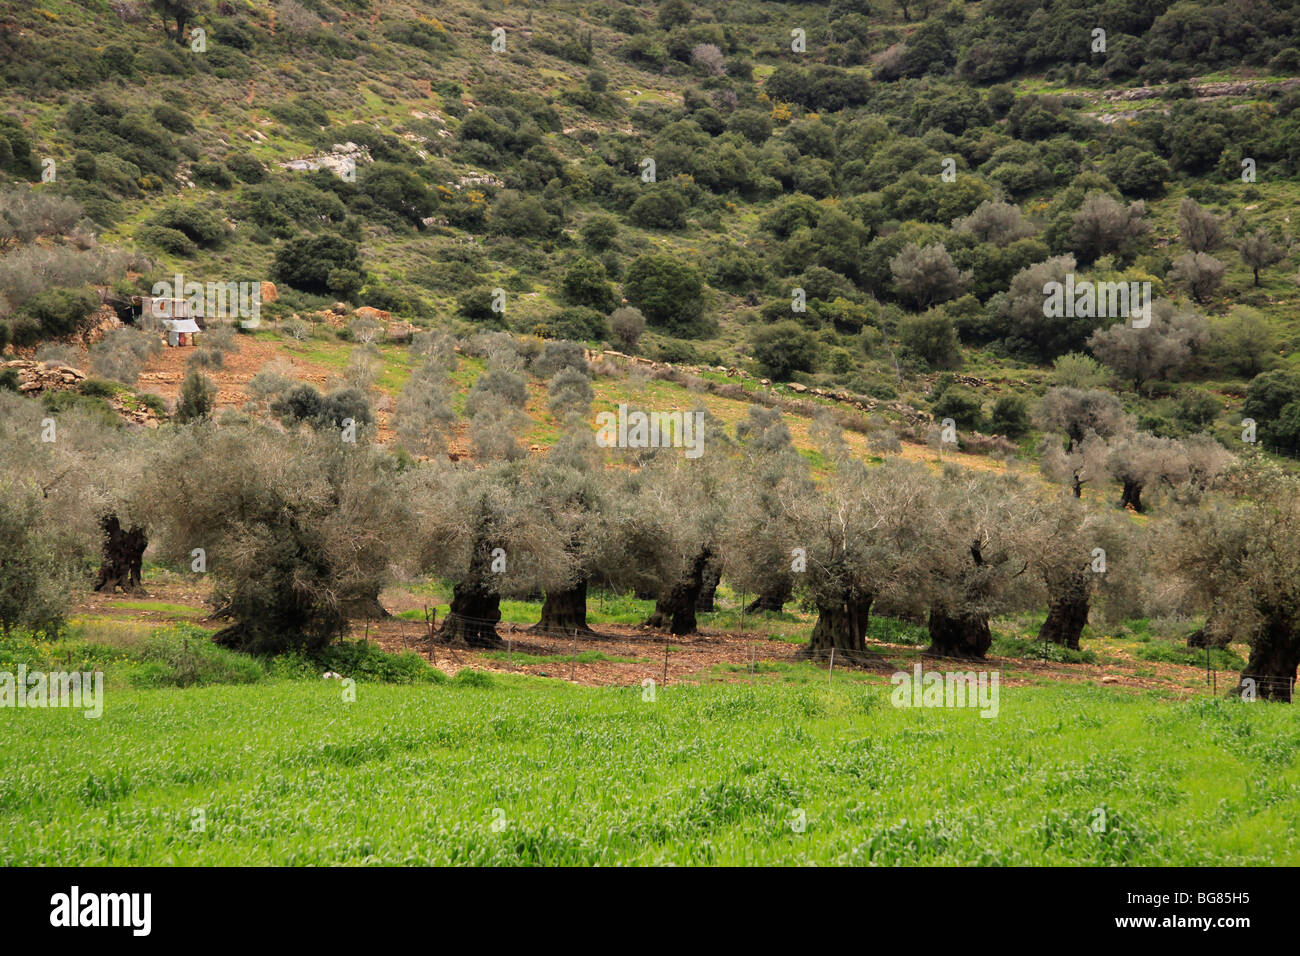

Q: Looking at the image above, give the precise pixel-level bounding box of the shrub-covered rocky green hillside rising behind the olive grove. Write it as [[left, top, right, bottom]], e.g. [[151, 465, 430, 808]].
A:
[[0, 0, 1300, 463]]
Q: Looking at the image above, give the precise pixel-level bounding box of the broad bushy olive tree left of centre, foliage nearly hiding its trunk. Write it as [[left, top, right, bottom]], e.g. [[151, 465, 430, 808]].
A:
[[153, 424, 404, 653]]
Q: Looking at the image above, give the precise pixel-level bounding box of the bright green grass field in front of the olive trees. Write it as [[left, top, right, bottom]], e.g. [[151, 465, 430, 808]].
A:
[[0, 667, 1300, 865]]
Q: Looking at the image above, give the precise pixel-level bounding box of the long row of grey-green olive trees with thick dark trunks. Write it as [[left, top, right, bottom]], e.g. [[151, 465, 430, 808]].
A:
[[10, 354, 1300, 697]]
